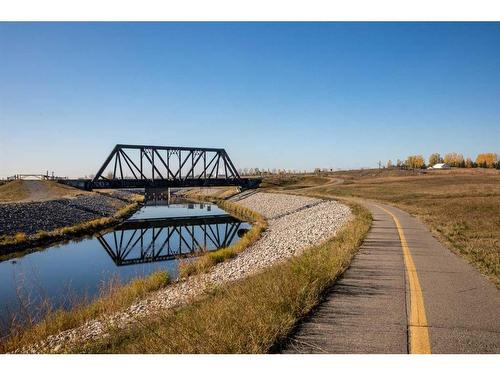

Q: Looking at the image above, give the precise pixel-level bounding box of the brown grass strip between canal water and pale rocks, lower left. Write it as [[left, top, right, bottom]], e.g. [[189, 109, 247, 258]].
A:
[[0, 271, 169, 353]]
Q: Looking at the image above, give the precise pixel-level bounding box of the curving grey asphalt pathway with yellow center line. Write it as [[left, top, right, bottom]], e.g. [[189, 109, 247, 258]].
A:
[[283, 201, 500, 353]]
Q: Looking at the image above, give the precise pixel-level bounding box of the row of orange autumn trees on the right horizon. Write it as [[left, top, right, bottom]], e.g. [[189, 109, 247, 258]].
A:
[[387, 152, 500, 169]]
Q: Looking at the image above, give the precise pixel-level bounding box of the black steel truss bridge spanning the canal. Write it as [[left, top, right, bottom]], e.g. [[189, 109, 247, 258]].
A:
[[61, 144, 260, 189]]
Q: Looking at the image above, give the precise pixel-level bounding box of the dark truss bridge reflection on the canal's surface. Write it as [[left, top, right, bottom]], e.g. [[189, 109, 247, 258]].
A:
[[97, 215, 249, 266]]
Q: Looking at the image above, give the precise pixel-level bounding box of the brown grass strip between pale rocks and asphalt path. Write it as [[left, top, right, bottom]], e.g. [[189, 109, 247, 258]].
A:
[[67, 201, 371, 353]]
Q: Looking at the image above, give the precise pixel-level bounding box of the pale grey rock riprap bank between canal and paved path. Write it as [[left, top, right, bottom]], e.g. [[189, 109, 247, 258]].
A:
[[20, 193, 351, 353]]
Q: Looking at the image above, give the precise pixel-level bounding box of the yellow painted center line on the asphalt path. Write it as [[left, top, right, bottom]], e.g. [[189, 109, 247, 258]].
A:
[[375, 205, 431, 354]]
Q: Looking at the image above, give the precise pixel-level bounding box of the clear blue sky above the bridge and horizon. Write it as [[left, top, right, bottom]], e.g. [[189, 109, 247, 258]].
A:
[[0, 23, 500, 176]]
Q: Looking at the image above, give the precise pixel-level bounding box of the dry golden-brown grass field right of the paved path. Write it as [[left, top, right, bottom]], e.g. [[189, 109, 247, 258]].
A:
[[268, 168, 500, 287]]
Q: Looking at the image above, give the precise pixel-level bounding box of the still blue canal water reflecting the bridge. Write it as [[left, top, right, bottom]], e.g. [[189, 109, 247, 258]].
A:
[[0, 201, 250, 330]]
